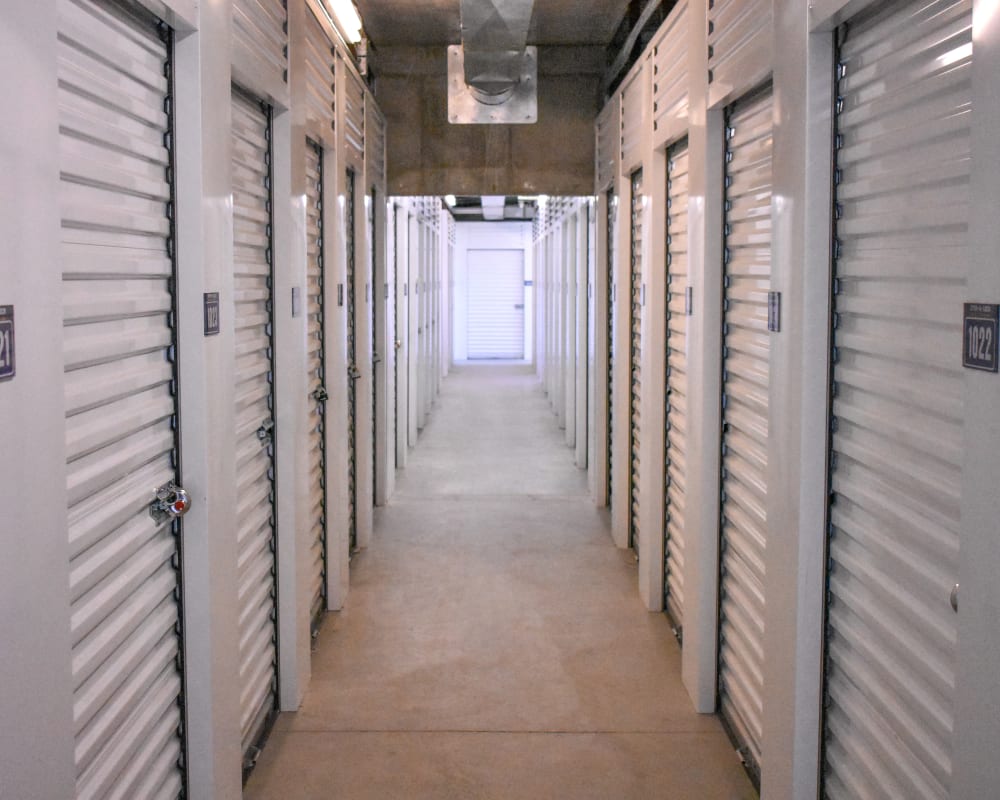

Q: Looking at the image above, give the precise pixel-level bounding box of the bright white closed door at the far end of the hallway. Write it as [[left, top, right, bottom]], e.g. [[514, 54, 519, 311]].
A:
[[467, 249, 524, 359]]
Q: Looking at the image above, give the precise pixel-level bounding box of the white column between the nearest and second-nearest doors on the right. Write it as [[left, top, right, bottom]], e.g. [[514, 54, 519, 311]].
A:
[[762, 0, 833, 800]]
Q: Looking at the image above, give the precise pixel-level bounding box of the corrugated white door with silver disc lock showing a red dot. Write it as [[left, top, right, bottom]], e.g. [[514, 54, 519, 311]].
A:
[[59, 0, 184, 798]]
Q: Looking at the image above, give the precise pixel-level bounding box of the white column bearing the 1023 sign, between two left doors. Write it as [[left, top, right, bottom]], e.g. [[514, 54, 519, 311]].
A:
[[175, 2, 243, 799]]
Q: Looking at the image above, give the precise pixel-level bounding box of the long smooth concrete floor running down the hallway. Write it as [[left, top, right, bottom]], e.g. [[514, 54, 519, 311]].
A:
[[246, 364, 756, 800]]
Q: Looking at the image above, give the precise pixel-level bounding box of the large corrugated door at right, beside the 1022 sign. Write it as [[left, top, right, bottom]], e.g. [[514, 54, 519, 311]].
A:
[[824, 0, 972, 800]]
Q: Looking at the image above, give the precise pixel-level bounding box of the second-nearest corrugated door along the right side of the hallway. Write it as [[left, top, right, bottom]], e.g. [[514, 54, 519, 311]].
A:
[[719, 90, 773, 778]]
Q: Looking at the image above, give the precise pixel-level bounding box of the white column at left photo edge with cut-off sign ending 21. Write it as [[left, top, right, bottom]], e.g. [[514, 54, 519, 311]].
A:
[[0, 0, 75, 800]]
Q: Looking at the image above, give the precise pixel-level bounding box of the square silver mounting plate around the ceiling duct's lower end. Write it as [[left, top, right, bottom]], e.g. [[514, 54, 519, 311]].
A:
[[448, 44, 538, 125]]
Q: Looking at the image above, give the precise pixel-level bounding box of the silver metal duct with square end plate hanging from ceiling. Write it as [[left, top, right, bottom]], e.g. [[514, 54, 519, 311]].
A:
[[448, 0, 538, 123]]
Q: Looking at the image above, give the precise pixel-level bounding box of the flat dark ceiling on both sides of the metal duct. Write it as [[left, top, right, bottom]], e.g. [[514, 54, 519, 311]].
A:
[[356, 0, 628, 48]]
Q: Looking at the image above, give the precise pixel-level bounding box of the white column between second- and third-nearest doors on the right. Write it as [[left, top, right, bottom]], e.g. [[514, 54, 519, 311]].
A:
[[681, 3, 723, 713]]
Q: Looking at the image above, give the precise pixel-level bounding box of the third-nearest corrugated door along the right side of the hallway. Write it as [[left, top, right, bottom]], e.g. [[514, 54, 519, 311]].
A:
[[663, 139, 688, 639]]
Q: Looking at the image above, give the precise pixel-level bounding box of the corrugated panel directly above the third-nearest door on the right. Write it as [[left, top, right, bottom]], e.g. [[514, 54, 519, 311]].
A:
[[653, 0, 689, 147]]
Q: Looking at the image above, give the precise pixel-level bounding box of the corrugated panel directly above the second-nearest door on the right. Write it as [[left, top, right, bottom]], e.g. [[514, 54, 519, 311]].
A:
[[708, 0, 772, 105]]
